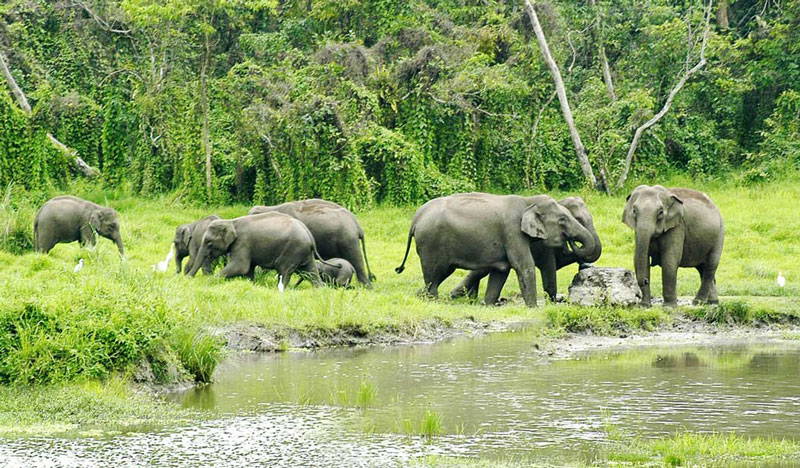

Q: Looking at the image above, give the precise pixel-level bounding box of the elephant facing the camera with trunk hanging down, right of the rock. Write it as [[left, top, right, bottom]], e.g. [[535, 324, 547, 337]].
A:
[[622, 185, 725, 307]]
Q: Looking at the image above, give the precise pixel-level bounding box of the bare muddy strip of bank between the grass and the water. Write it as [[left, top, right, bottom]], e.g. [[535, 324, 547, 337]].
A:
[[141, 298, 800, 394]]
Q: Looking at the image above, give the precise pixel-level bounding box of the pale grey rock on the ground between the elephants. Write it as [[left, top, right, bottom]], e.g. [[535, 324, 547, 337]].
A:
[[569, 268, 642, 306]]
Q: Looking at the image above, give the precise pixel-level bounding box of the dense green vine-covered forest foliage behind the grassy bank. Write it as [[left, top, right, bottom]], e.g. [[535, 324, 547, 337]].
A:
[[0, 0, 800, 207]]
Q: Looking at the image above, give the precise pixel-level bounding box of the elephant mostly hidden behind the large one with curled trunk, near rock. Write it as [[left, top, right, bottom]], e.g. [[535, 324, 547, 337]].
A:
[[450, 197, 603, 301]]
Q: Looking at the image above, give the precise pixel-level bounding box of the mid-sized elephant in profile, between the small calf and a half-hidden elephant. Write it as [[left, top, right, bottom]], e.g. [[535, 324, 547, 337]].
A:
[[189, 213, 322, 287]]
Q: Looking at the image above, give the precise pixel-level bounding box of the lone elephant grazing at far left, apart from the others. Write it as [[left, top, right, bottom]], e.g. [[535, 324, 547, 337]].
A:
[[33, 195, 125, 255]]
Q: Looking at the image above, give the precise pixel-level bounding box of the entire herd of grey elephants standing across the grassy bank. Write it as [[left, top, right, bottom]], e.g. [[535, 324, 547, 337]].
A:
[[34, 185, 724, 307]]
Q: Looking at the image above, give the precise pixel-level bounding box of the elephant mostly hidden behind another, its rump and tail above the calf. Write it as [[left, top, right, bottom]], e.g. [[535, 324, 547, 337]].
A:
[[250, 198, 375, 288]]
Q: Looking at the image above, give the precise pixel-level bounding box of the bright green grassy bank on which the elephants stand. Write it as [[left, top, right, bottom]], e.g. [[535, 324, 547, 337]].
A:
[[0, 181, 800, 432]]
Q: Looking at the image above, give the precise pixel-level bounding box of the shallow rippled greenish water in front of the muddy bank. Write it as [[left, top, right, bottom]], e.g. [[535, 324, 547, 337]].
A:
[[0, 332, 800, 466]]
